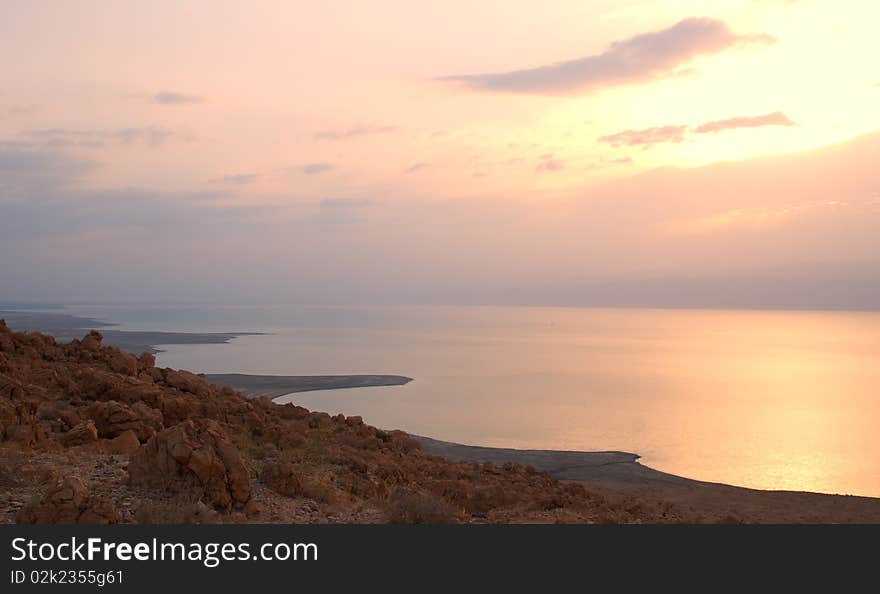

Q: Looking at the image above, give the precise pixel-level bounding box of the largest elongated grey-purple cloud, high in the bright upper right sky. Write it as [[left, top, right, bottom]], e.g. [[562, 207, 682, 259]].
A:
[[441, 18, 775, 94]]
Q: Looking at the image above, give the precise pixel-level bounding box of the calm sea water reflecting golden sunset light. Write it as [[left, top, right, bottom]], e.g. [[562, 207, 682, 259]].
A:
[[67, 306, 880, 496]]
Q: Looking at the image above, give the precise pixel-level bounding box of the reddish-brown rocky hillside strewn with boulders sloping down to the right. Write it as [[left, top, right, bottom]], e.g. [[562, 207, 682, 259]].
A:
[[0, 321, 694, 523]]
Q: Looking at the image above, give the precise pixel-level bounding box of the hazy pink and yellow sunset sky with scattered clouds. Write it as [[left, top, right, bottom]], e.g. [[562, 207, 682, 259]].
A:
[[0, 0, 880, 309]]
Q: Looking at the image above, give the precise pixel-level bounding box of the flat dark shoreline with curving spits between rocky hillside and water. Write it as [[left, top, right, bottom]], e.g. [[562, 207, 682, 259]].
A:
[[6, 310, 880, 523]]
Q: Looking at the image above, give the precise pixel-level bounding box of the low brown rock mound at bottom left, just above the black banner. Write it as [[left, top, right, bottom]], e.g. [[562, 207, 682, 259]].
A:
[[16, 476, 118, 524]]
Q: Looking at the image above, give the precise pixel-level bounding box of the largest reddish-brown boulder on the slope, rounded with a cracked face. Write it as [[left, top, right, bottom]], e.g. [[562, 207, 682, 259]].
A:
[[128, 420, 253, 510]]
